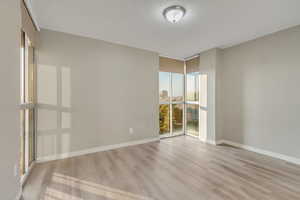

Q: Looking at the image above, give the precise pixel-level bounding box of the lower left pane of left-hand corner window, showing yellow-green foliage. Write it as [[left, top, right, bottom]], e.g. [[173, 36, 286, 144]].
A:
[[159, 104, 170, 135]]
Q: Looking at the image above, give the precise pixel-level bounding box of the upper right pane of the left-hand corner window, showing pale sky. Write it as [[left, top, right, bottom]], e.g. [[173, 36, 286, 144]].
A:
[[172, 73, 184, 101]]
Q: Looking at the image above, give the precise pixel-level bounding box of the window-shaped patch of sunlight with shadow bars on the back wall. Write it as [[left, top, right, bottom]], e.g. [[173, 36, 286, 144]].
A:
[[37, 64, 72, 158]]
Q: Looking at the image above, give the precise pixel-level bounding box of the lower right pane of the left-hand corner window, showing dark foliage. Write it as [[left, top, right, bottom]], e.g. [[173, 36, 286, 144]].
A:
[[172, 104, 183, 134]]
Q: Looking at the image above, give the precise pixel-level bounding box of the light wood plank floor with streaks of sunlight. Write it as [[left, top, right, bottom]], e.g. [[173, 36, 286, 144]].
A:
[[24, 136, 300, 200]]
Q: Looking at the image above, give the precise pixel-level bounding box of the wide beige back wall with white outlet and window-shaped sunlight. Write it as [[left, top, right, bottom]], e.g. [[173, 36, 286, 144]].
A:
[[38, 30, 159, 158]]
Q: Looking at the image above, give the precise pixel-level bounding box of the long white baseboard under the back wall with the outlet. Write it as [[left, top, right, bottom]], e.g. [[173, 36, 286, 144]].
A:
[[36, 137, 160, 163]]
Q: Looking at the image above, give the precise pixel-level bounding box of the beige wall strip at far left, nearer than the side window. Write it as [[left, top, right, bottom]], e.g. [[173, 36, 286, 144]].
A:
[[0, 0, 21, 200]]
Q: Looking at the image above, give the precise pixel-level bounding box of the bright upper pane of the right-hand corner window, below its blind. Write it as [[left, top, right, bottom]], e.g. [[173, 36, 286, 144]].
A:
[[186, 73, 199, 101]]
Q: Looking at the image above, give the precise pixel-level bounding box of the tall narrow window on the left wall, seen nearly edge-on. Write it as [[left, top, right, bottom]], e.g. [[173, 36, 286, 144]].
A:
[[20, 32, 36, 176]]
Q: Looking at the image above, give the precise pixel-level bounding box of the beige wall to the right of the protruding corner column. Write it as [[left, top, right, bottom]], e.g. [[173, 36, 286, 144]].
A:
[[219, 26, 300, 158]]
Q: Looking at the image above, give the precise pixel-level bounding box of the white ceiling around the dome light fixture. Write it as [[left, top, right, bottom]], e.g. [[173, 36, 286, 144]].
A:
[[33, 0, 300, 58]]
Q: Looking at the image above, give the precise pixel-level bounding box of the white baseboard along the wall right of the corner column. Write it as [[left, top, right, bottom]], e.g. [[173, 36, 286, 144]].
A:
[[216, 140, 300, 165]]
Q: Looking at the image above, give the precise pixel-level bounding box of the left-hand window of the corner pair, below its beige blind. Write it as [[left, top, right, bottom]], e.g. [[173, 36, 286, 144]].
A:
[[159, 72, 184, 137]]
